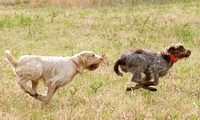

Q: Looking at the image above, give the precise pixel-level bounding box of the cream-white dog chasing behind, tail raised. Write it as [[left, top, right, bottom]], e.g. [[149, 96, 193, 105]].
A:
[[5, 50, 103, 104]]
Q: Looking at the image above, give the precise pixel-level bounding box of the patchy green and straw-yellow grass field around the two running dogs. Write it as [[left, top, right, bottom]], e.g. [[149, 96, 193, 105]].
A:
[[0, 2, 200, 120]]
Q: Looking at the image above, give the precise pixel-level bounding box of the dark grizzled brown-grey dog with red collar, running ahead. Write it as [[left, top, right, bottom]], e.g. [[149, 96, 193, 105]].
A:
[[114, 44, 191, 91]]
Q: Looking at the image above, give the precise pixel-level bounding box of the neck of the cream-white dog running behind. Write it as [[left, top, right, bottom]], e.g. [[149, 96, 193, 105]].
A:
[[71, 56, 85, 74]]
